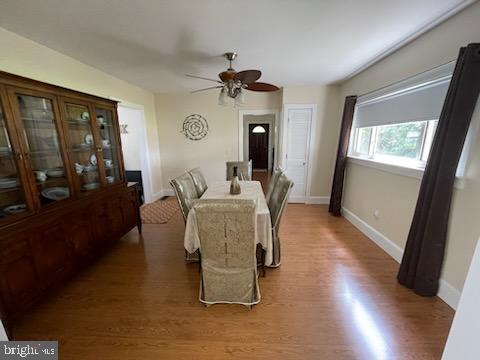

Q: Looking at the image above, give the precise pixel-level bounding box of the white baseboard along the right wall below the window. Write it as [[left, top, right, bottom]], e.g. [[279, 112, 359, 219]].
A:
[[342, 207, 461, 310]]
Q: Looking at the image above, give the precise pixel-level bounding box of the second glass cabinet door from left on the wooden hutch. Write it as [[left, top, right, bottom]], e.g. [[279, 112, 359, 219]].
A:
[[14, 93, 70, 207]]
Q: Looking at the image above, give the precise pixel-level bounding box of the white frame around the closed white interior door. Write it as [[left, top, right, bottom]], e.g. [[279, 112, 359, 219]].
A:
[[280, 104, 317, 204]]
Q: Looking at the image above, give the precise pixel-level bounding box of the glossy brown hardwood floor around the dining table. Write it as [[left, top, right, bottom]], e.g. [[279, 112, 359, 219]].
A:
[[14, 204, 453, 360]]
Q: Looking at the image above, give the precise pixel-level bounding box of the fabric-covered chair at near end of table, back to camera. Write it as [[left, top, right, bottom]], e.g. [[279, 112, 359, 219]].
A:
[[194, 199, 260, 308]]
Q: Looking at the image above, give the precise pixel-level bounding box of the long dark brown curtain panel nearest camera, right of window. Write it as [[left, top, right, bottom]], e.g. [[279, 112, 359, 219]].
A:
[[398, 44, 480, 296]]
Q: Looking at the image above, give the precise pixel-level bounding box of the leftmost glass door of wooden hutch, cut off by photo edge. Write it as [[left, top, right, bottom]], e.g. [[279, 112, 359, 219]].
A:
[[0, 95, 29, 221]]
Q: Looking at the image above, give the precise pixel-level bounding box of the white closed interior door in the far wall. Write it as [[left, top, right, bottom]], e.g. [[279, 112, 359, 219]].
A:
[[285, 108, 313, 203]]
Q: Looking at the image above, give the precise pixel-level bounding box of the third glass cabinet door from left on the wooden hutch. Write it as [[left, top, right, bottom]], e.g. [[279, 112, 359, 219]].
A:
[[64, 100, 101, 193]]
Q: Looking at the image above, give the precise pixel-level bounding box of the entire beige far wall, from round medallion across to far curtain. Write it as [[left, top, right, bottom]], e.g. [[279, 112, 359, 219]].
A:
[[155, 86, 340, 196]]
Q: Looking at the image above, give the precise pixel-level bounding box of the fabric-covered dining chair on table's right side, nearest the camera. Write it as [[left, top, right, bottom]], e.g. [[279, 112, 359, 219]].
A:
[[268, 174, 293, 267]]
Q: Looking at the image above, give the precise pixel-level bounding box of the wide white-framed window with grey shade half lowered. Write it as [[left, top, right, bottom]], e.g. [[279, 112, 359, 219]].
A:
[[349, 68, 452, 170]]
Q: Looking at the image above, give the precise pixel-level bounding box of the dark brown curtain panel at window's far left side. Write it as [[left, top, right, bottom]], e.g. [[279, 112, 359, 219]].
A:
[[328, 95, 357, 216]]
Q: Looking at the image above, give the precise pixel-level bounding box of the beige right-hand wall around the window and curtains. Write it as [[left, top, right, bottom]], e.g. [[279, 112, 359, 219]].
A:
[[341, 3, 480, 290]]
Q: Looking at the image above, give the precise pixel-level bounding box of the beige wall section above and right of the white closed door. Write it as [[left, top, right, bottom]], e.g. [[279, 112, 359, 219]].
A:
[[282, 85, 341, 197]]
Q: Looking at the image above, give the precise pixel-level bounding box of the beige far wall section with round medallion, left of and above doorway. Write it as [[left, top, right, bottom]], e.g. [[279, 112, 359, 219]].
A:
[[155, 90, 281, 190]]
